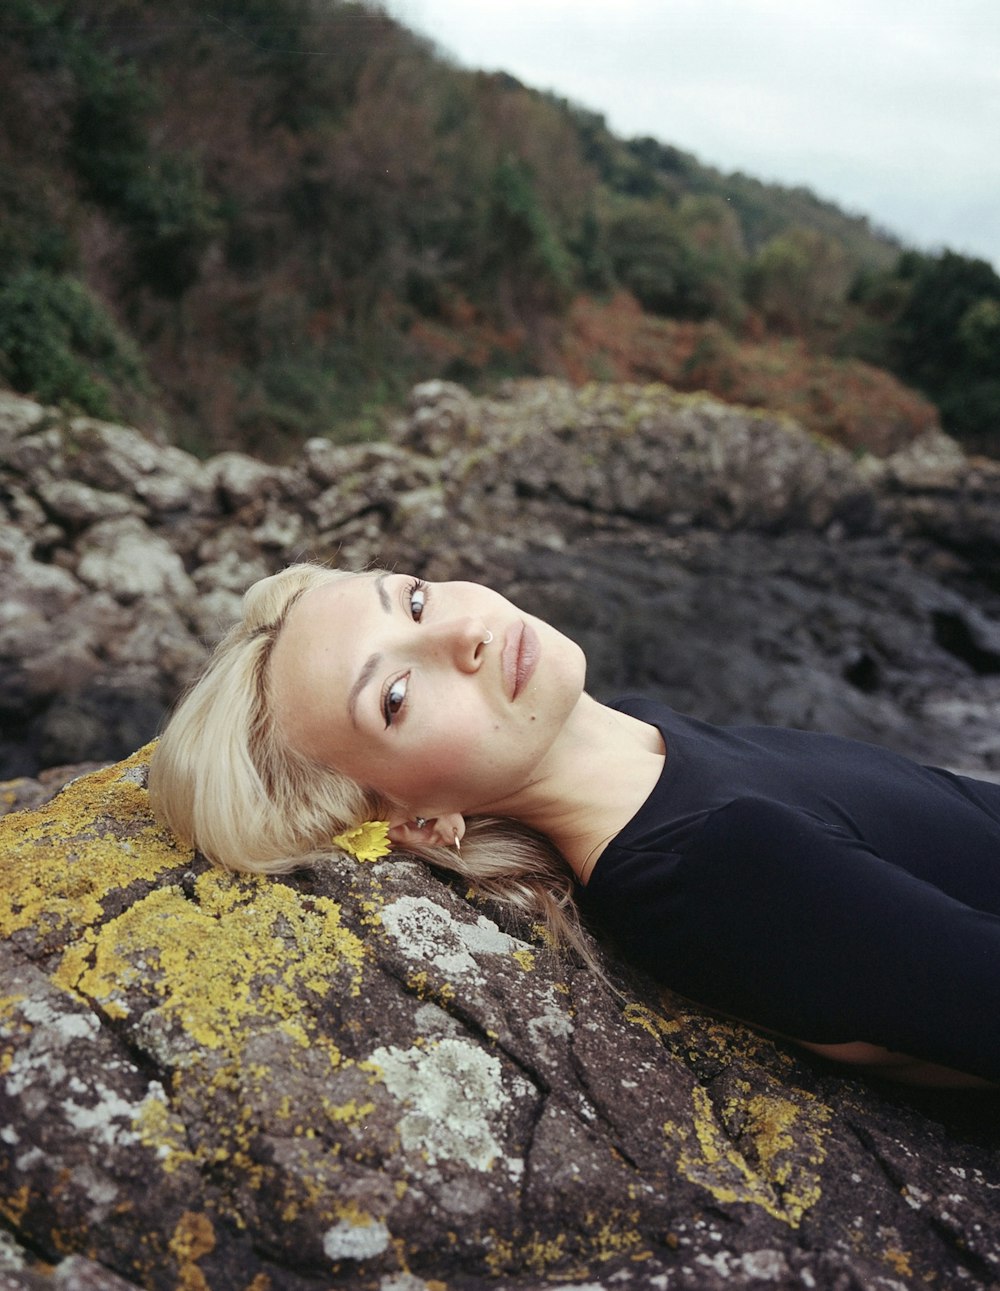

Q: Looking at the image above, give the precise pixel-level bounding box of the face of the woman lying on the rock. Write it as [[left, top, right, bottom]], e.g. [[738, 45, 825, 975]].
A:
[[271, 573, 586, 818]]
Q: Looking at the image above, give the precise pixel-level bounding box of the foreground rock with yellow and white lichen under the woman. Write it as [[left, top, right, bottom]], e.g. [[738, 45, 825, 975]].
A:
[[0, 753, 1000, 1291]]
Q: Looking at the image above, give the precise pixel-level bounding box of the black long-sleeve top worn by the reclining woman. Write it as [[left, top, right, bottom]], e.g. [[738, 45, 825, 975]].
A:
[[578, 698, 1000, 1079]]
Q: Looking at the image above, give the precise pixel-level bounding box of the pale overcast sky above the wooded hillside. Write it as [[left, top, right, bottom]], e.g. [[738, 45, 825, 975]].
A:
[[386, 0, 1000, 270]]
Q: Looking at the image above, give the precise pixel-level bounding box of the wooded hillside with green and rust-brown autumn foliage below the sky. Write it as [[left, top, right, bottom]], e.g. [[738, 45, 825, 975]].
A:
[[0, 0, 1000, 460]]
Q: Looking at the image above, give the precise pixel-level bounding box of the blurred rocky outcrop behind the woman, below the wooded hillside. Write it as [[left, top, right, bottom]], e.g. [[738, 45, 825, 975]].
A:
[[0, 381, 1000, 777]]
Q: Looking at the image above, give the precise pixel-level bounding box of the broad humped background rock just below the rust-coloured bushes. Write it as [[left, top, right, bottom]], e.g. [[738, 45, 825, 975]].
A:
[[451, 382, 875, 532]]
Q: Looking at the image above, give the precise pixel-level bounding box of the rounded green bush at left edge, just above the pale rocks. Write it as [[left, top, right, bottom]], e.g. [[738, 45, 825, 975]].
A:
[[0, 269, 145, 417]]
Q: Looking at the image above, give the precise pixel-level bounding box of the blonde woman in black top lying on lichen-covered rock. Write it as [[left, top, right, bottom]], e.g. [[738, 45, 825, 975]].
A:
[[150, 564, 1000, 1084]]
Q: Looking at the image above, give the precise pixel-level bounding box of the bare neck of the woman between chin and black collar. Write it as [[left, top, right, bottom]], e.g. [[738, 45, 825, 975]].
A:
[[500, 695, 666, 883]]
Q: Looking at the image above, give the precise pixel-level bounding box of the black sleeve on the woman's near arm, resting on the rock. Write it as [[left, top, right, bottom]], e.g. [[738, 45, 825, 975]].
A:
[[615, 798, 1000, 1079]]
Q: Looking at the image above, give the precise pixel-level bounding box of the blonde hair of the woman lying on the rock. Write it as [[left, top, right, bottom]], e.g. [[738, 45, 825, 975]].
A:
[[150, 564, 600, 972]]
